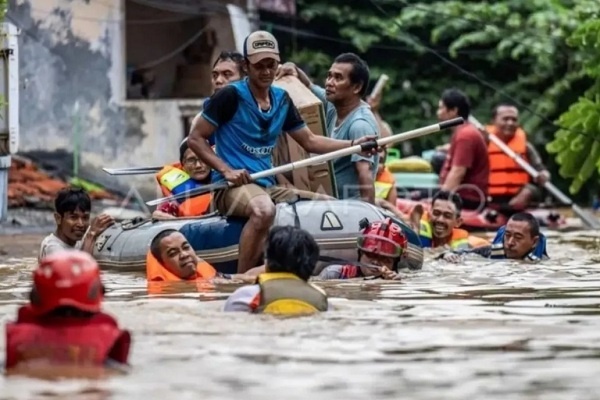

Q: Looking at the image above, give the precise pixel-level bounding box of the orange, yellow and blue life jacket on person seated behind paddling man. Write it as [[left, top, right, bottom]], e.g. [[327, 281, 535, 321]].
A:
[[156, 163, 212, 217]]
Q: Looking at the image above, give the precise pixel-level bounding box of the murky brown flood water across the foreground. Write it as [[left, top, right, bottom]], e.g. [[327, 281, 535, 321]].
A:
[[0, 228, 600, 400]]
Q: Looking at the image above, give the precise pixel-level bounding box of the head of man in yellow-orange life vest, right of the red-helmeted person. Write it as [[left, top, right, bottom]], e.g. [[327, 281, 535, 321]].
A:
[[429, 190, 462, 239]]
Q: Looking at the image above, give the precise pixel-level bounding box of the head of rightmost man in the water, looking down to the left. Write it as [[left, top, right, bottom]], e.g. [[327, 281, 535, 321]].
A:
[[504, 212, 540, 259]]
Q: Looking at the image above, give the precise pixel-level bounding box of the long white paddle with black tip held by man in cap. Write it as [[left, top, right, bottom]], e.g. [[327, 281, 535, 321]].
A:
[[146, 117, 464, 206]]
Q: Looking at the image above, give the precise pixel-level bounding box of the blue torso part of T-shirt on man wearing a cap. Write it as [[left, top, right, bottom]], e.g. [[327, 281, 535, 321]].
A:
[[212, 78, 289, 187]]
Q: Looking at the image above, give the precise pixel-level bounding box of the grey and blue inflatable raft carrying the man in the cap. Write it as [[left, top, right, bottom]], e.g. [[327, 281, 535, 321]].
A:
[[94, 200, 424, 273]]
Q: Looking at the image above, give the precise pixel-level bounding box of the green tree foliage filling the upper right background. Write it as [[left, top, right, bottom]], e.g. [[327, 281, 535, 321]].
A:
[[263, 0, 600, 200]]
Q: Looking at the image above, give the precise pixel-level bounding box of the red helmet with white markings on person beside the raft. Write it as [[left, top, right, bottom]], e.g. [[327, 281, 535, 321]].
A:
[[357, 218, 408, 258]]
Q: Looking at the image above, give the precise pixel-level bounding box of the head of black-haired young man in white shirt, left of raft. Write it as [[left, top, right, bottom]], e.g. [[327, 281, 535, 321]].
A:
[[54, 187, 92, 245]]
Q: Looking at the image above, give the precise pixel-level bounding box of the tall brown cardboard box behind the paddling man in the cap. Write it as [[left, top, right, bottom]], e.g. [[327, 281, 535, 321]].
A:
[[273, 76, 337, 197]]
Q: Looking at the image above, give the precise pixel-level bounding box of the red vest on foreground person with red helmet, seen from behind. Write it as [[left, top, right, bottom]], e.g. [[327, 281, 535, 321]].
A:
[[6, 306, 131, 368]]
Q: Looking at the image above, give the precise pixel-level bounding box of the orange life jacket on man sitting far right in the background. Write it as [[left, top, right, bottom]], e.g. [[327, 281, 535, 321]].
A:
[[486, 125, 529, 196]]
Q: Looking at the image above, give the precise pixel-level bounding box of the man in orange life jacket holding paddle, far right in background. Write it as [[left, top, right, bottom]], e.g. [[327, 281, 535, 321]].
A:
[[486, 104, 550, 210]]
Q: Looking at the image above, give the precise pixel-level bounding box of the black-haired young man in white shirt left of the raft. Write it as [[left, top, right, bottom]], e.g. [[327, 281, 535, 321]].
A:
[[38, 187, 114, 261]]
